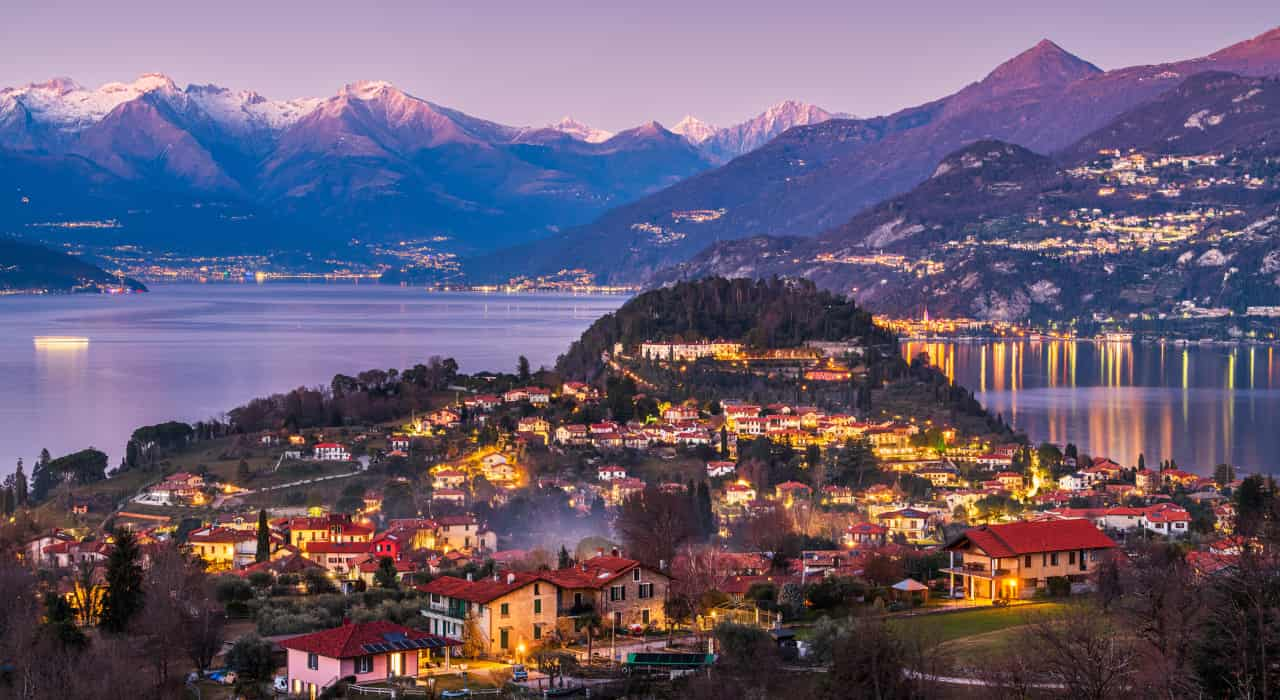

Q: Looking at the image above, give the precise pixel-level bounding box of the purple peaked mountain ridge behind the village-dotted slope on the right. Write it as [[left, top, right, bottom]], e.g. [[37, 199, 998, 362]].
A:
[[467, 29, 1280, 284]]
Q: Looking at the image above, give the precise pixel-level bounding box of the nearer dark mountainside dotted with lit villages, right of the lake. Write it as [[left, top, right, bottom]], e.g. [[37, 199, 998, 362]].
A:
[[658, 72, 1280, 321]]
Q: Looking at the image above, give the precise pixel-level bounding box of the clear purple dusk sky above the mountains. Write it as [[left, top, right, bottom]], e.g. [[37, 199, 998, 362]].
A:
[[0, 0, 1280, 129]]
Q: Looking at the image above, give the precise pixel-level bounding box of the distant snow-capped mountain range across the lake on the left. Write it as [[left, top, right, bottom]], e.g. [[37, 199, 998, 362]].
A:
[[0, 74, 827, 251]]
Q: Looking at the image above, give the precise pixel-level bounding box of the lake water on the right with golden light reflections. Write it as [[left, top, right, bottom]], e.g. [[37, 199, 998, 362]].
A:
[[902, 340, 1280, 473]]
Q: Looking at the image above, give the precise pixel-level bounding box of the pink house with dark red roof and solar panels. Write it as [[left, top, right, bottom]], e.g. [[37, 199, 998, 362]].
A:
[[280, 621, 462, 700]]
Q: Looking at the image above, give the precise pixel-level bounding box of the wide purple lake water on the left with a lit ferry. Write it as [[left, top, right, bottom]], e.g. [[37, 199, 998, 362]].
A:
[[0, 283, 626, 475]]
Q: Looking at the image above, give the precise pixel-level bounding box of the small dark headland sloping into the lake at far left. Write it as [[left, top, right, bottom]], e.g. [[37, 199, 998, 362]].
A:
[[0, 235, 146, 292]]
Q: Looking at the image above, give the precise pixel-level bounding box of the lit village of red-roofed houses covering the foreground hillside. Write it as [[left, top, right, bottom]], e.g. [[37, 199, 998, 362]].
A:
[[0, 280, 1270, 697]]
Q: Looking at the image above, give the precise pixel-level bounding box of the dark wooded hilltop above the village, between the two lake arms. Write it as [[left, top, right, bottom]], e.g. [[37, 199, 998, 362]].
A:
[[556, 278, 893, 379]]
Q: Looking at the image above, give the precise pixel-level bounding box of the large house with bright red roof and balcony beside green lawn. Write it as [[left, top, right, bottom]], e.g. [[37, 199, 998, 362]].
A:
[[942, 518, 1116, 600]]
